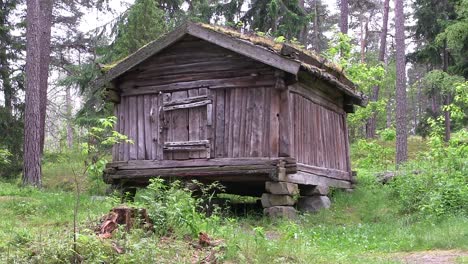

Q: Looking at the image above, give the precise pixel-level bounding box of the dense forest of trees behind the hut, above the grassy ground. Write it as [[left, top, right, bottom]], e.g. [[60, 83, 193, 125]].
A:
[[0, 0, 468, 184]]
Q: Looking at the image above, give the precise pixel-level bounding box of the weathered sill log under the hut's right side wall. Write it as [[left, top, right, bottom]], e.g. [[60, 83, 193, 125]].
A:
[[286, 171, 351, 189]]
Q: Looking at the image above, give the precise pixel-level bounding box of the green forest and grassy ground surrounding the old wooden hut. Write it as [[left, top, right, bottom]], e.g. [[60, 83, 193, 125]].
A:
[[0, 0, 468, 263]]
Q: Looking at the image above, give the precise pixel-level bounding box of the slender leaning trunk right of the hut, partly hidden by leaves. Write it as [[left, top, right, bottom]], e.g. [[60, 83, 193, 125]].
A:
[[366, 0, 390, 138]]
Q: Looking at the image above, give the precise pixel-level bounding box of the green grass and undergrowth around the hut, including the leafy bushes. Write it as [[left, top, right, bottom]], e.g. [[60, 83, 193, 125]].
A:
[[0, 128, 468, 263]]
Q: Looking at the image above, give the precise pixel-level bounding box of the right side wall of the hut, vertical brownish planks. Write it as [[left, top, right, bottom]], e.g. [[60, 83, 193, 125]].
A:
[[289, 84, 350, 173]]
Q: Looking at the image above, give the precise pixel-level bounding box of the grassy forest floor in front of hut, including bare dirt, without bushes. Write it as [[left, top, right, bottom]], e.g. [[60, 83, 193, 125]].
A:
[[0, 137, 468, 264]]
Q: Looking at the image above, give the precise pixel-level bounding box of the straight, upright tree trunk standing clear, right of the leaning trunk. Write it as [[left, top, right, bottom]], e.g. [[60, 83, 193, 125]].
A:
[[395, 0, 408, 164]]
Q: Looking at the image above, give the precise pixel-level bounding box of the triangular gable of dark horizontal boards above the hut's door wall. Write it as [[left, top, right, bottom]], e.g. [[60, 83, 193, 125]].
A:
[[115, 35, 275, 96]]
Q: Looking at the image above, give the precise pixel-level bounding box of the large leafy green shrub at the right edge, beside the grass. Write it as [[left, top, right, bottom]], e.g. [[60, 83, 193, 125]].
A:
[[391, 130, 468, 216]]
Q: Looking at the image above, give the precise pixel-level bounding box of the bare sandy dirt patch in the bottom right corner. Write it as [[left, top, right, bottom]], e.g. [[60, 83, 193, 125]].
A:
[[395, 250, 468, 264]]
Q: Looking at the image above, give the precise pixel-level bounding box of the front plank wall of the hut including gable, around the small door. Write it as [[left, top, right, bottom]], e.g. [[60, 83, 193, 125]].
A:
[[113, 37, 279, 161]]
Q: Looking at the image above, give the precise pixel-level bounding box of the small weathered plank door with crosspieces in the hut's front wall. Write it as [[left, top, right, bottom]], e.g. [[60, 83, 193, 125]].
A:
[[160, 88, 213, 160]]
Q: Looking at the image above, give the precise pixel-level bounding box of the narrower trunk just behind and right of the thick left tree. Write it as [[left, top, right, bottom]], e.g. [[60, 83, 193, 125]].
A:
[[39, 0, 52, 153]]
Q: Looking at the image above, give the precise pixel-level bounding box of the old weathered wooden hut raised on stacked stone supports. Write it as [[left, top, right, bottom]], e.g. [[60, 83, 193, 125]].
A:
[[95, 23, 365, 215]]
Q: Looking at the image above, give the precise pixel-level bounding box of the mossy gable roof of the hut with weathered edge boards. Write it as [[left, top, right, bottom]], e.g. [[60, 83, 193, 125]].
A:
[[93, 22, 366, 106]]
